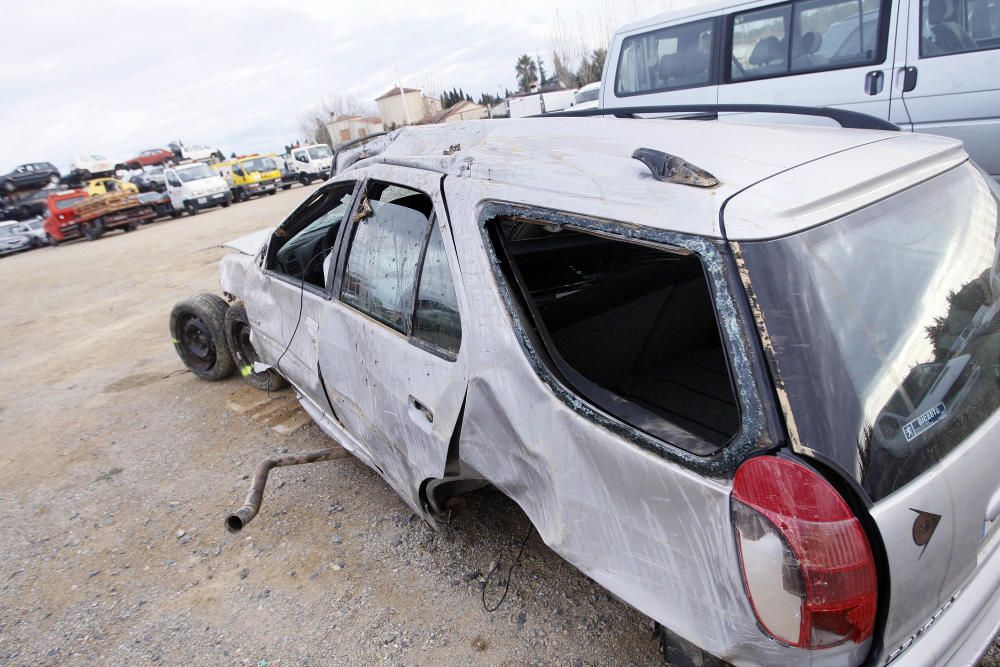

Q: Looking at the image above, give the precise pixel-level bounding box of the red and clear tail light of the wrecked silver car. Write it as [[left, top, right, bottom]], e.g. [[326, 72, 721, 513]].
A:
[[732, 456, 878, 649]]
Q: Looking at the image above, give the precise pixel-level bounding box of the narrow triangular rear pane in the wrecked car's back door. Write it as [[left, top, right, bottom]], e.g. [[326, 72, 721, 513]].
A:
[[413, 224, 462, 358]]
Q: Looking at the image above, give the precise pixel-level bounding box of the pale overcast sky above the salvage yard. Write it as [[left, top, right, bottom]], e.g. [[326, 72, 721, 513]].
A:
[[0, 0, 693, 173]]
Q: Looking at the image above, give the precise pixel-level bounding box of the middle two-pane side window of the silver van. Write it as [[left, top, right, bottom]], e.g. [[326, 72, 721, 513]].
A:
[[729, 0, 885, 81]]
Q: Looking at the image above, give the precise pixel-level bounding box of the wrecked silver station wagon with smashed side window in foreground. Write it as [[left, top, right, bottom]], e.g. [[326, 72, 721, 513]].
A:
[[170, 112, 1000, 665]]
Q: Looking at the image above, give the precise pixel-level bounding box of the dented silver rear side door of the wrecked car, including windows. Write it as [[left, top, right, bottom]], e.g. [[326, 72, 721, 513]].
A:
[[320, 165, 468, 498]]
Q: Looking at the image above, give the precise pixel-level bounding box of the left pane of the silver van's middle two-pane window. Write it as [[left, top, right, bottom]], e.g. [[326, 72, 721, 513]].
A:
[[731, 5, 792, 81]]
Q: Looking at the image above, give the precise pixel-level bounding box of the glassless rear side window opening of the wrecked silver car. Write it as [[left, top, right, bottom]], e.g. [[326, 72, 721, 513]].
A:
[[488, 218, 740, 455]]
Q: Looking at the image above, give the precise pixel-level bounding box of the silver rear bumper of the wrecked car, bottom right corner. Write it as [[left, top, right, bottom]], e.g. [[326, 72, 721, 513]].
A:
[[878, 531, 1000, 667]]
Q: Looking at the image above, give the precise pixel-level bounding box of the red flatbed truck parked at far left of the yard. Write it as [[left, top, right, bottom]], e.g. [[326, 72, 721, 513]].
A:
[[45, 190, 156, 245]]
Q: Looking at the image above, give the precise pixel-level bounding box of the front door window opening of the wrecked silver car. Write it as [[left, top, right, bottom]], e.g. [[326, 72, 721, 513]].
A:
[[269, 181, 355, 289]]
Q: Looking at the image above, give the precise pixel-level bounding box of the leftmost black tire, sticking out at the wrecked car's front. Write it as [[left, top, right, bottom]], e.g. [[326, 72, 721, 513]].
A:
[[170, 292, 236, 382]]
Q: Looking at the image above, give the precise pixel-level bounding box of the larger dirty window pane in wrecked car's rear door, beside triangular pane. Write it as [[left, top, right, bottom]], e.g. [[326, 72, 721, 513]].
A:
[[341, 182, 433, 335]]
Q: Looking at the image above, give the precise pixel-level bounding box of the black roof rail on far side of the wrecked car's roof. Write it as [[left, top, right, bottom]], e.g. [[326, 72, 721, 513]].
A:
[[531, 104, 899, 132]]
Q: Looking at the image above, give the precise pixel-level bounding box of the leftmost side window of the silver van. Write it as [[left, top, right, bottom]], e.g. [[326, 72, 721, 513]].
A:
[[615, 19, 715, 96]]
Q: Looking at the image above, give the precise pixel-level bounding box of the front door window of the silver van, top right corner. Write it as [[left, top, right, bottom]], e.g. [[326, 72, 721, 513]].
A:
[[920, 0, 1000, 58]]
